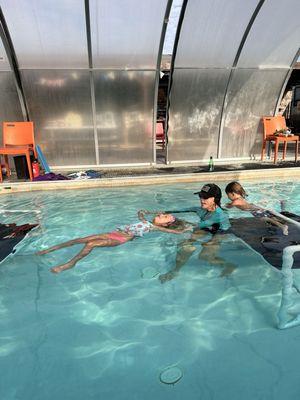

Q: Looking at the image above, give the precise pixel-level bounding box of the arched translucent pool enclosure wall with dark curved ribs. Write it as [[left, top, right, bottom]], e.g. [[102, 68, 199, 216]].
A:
[[0, 0, 300, 167]]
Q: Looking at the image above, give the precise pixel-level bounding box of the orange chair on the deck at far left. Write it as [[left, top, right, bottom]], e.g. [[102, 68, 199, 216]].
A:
[[0, 122, 37, 182]]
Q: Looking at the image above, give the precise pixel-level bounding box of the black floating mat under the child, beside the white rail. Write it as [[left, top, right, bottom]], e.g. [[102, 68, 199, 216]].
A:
[[230, 213, 300, 268]]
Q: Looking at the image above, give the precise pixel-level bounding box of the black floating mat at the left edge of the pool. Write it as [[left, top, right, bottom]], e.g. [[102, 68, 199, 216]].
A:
[[0, 224, 37, 262]]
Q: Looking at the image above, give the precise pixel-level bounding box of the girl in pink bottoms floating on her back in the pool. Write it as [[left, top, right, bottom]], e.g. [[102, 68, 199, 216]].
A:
[[37, 210, 191, 274]]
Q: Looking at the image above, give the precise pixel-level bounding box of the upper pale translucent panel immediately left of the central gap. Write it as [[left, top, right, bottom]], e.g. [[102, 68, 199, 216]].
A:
[[90, 0, 167, 69]]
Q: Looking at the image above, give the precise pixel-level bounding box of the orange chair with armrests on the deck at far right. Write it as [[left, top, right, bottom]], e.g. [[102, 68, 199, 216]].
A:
[[261, 115, 299, 164]]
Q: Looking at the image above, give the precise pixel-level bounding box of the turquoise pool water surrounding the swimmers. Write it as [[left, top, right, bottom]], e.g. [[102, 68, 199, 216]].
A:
[[0, 181, 300, 400]]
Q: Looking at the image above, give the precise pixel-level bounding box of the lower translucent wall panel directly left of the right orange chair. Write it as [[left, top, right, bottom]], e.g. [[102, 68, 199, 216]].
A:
[[221, 69, 287, 158]]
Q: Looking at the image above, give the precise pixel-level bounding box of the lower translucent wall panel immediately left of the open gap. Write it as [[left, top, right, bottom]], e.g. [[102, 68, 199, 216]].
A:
[[94, 71, 155, 164]]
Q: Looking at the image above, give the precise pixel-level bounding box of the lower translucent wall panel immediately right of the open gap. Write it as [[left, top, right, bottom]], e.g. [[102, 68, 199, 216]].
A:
[[168, 69, 229, 161]]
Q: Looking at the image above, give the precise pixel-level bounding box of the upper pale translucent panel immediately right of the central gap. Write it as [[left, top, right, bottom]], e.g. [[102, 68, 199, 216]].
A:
[[176, 0, 258, 68]]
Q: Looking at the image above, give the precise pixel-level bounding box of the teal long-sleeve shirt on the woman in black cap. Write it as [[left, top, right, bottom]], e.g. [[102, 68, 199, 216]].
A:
[[167, 207, 230, 231]]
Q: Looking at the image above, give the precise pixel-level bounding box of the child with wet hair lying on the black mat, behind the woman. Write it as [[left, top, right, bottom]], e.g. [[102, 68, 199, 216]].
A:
[[225, 182, 288, 235]]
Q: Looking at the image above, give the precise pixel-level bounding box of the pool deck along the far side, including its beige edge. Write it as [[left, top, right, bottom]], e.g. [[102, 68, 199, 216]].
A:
[[0, 163, 300, 194]]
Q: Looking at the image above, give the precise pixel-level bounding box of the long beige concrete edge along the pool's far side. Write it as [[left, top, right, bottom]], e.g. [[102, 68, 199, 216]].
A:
[[0, 167, 300, 195]]
